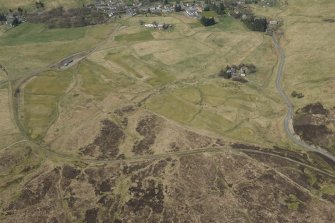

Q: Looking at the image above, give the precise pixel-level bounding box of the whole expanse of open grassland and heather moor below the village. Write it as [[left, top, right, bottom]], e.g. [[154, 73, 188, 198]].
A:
[[0, 0, 335, 222]]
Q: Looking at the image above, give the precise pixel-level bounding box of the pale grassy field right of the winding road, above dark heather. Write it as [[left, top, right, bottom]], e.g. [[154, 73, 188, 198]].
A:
[[282, 0, 335, 108]]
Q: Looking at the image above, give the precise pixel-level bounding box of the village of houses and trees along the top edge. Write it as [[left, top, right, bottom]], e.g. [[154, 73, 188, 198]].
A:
[[0, 0, 279, 30]]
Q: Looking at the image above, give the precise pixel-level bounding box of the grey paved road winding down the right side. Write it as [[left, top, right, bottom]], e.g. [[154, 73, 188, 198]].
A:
[[272, 34, 335, 162]]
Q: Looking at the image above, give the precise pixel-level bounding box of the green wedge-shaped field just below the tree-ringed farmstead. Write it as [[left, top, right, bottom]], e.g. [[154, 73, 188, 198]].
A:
[[146, 79, 282, 144]]
